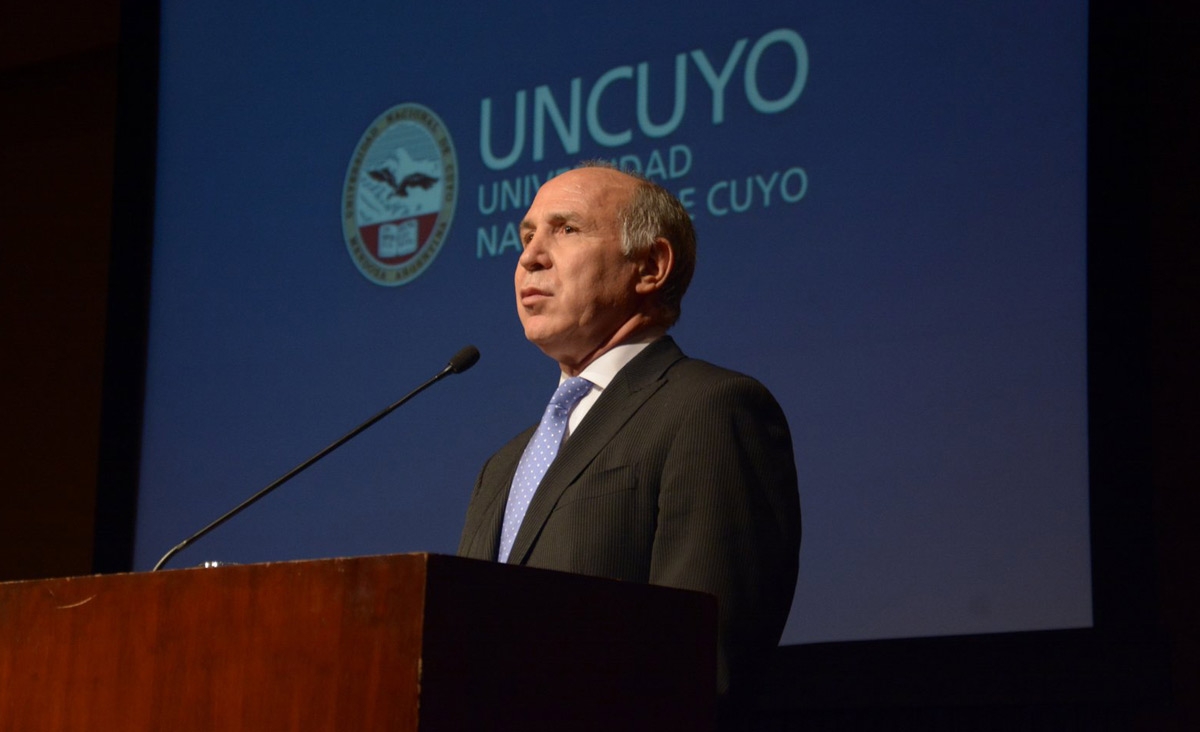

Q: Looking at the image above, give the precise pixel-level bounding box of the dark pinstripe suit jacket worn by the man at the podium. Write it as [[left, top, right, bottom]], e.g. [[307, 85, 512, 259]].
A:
[[458, 338, 800, 694]]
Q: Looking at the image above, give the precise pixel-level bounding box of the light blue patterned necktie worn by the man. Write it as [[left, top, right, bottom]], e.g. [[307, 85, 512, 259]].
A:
[[497, 376, 592, 562]]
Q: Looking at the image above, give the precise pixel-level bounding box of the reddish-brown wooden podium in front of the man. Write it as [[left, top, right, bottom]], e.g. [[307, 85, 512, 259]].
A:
[[0, 554, 716, 732]]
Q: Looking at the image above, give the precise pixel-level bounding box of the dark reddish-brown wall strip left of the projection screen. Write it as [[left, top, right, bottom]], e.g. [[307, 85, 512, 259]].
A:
[[0, 0, 119, 580]]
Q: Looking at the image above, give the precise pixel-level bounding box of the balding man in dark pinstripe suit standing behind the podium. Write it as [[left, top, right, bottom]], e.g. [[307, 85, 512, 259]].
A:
[[458, 160, 800, 720]]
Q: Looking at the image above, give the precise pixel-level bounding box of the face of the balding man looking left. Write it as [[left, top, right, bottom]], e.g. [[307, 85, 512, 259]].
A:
[[515, 168, 640, 372]]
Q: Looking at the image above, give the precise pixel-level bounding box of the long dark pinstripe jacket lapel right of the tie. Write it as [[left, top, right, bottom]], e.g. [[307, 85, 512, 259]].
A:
[[497, 337, 684, 564]]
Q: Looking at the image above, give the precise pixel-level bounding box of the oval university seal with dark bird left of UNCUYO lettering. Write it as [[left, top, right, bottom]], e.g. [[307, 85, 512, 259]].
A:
[[342, 104, 458, 287]]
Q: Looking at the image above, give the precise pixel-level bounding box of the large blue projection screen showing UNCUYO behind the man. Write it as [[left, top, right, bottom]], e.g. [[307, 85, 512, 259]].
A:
[[134, 0, 1092, 643]]
